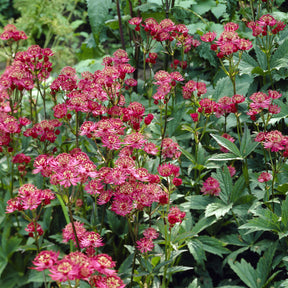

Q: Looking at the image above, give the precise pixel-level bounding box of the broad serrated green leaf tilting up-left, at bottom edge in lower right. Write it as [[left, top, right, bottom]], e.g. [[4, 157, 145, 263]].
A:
[[228, 259, 260, 288]]
